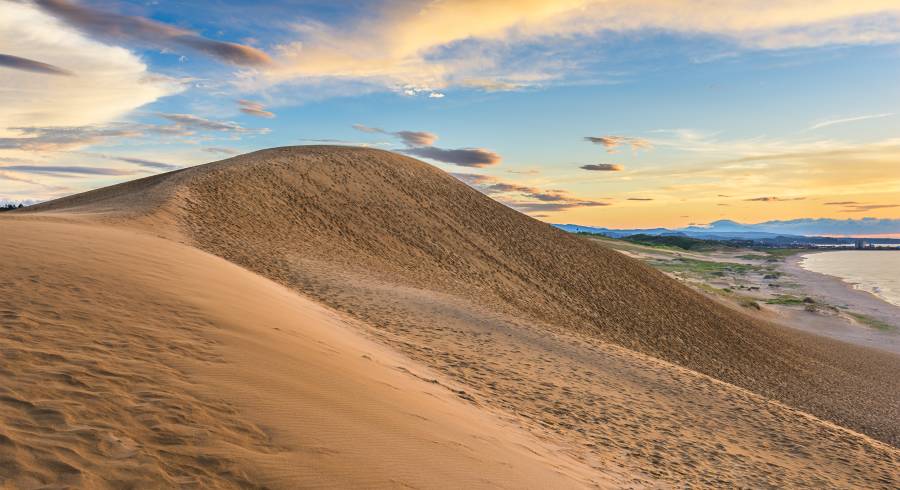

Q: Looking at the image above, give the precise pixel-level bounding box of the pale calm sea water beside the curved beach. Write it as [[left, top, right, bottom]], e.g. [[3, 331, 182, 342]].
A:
[[800, 250, 900, 306]]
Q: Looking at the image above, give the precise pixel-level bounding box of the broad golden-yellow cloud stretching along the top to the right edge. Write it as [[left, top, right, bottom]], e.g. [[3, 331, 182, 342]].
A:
[[248, 0, 900, 91]]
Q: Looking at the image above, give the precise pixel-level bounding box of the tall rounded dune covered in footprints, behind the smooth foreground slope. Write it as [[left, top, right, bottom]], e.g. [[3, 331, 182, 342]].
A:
[[9, 147, 900, 488]]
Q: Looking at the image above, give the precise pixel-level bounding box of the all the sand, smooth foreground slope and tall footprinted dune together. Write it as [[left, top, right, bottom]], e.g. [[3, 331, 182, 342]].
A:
[[7, 147, 900, 488]]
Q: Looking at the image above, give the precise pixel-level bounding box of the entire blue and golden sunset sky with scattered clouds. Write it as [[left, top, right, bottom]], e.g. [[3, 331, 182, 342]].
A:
[[0, 0, 900, 236]]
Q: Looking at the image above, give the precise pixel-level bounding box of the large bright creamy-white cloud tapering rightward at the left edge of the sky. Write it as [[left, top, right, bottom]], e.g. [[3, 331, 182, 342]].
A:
[[0, 2, 184, 130]]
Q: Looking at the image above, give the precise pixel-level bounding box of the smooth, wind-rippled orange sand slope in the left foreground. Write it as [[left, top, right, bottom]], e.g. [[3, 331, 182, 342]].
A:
[[0, 219, 611, 488]]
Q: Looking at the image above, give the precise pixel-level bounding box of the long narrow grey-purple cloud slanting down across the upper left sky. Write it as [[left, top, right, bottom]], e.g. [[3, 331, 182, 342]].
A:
[[34, 0, 272, 66]]
